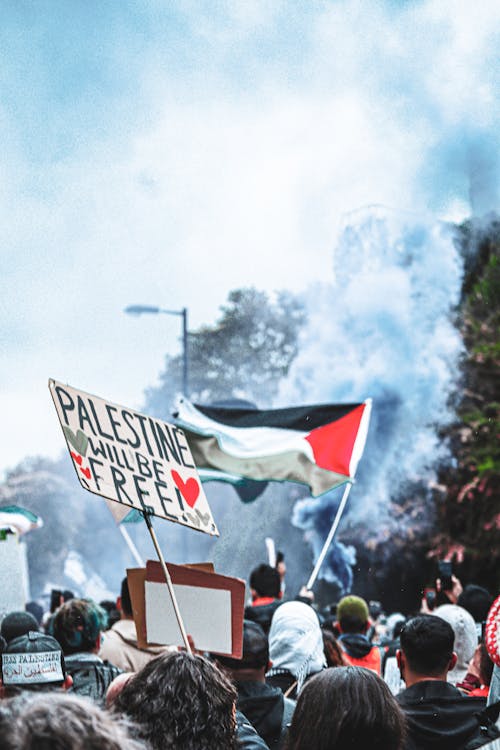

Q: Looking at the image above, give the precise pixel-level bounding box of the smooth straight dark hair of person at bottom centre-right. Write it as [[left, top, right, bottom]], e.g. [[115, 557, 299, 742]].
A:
[[286, 667, 406, 750]]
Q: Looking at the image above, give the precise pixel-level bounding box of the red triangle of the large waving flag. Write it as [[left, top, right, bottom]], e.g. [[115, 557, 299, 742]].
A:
[[305, 404, 366, 477]]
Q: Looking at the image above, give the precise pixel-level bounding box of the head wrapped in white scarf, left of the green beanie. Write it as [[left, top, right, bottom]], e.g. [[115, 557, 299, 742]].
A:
[[269, 602, 326, 690]]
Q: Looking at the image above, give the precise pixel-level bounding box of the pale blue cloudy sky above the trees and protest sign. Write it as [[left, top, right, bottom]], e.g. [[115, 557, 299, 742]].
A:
[[0, 0, 500, 475]]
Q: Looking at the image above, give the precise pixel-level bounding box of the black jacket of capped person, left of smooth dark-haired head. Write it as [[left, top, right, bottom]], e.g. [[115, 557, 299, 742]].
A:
[[236, 682, 295, 749]]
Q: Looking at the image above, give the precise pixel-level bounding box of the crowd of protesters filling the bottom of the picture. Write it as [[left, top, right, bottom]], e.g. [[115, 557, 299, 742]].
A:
[[0, 563, 500, 750]]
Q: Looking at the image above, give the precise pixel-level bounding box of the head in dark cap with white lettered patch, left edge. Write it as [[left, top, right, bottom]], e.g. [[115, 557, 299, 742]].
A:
[[0, 631, 72, 698]]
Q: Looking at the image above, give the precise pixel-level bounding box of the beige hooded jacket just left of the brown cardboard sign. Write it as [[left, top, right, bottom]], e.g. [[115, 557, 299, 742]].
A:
[[99, 620, 172, 672]]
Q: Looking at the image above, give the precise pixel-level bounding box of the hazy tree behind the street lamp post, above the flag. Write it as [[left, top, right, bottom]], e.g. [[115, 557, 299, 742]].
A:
[[146, 288, 305, 419]]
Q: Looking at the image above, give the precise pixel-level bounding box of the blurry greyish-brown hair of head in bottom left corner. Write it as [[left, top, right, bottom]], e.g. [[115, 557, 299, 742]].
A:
[[0, 693, 143, 750]]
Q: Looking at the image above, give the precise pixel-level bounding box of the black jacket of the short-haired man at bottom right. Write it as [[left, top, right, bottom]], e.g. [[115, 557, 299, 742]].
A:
[[396, 680, 498, 750]]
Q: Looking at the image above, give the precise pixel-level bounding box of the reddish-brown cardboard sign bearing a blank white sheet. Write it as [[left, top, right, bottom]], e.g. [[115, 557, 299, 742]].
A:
[[127, 561, 245, 659]]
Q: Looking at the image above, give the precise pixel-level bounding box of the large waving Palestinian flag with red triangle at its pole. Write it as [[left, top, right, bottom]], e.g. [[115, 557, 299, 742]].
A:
[[174, 399, 371, 497]]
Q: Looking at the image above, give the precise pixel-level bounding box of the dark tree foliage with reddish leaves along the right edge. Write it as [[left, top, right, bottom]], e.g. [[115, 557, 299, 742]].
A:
[[434, 218, 500, 589]]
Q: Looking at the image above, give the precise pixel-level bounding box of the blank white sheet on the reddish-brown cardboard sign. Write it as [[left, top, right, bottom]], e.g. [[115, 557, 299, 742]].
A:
[[145, 581, 232, 654]]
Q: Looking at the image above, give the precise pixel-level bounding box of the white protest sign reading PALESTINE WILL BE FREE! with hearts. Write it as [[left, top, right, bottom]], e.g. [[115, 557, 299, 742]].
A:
[[49, 380, 219, 536]]
